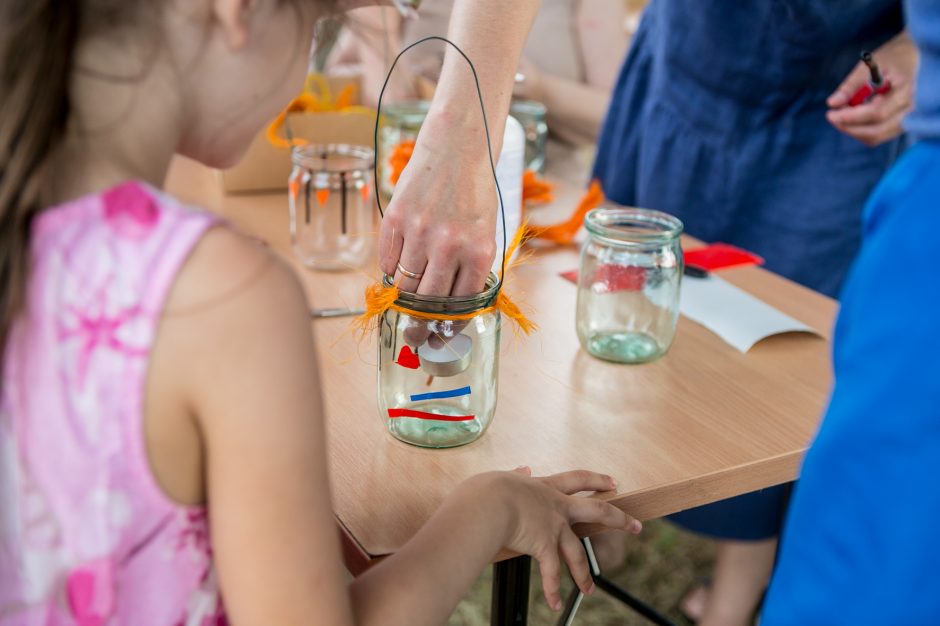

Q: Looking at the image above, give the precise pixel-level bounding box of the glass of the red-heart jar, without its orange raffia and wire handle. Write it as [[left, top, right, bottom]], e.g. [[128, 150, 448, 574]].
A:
[[378, 274, 500, 448]]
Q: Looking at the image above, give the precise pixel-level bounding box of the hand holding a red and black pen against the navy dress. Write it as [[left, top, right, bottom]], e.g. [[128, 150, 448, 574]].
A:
[[826, 32, 917, 146]]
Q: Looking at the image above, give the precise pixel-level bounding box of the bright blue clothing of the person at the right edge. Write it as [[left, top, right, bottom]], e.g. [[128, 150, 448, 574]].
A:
[[761, 0, 940, 626]]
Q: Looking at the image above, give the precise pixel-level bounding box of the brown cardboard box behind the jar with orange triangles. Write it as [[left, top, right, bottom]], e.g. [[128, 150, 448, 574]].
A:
[[219, 77, 375, 193]]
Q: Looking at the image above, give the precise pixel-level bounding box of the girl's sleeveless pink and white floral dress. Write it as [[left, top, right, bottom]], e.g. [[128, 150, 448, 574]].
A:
[[0, 182, 225, 626]]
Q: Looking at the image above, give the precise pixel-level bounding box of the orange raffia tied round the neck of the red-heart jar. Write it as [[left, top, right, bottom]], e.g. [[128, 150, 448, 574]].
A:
[[353, 227, 538, 335]]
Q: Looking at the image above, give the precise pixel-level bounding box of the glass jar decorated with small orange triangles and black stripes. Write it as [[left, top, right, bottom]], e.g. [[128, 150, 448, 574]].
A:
[[288, 144, 377, 270]]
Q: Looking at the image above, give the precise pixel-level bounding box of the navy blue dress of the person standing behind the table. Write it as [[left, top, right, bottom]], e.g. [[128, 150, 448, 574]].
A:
[[594, 0, 903, 540]]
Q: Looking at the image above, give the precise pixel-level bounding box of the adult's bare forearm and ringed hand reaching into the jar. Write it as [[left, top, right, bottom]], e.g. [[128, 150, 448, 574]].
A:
[[379, 0, 540, 296]]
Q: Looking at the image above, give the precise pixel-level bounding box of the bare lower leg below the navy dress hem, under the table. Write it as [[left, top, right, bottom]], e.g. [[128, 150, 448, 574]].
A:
[[699, 539, 777, 626]]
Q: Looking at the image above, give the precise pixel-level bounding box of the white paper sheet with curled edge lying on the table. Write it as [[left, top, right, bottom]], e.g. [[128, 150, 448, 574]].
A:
[[679, 274, 819, 352]]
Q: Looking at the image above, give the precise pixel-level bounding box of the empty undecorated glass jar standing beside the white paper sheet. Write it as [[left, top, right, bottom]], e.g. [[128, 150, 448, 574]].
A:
[[577, 208, 683, 363]]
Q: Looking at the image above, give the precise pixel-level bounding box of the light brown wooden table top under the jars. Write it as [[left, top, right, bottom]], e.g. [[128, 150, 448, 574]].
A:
[[169, 156, 836, 620]]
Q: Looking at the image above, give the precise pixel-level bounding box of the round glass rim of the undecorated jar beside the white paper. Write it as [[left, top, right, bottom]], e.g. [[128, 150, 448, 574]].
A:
[[584, 207, 683, 246]]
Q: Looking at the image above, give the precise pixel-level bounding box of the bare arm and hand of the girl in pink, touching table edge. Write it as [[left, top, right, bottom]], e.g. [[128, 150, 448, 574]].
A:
[[154, 229, 639, 626]]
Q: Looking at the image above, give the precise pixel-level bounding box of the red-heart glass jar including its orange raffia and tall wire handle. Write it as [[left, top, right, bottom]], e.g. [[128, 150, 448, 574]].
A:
[[356, 36, 535, 448]]
